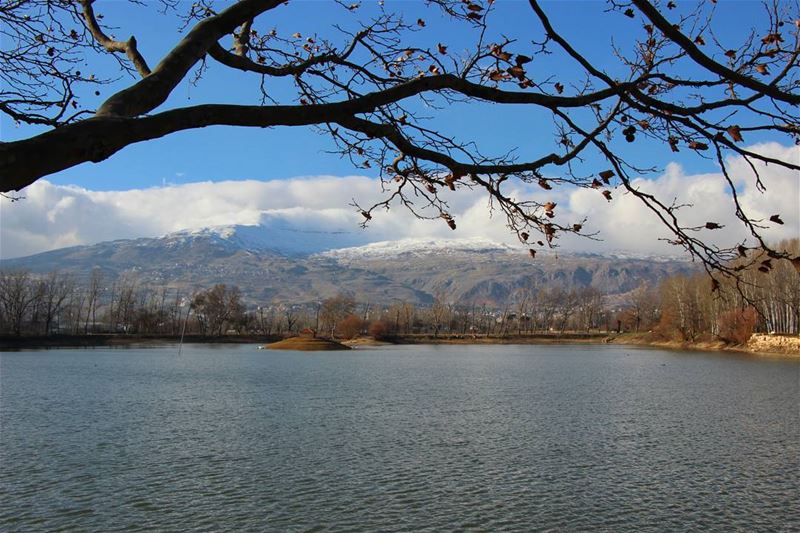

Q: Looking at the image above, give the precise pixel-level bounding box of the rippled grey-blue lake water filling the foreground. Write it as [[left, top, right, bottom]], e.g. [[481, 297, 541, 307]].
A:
[[0, 345, 800, 531]]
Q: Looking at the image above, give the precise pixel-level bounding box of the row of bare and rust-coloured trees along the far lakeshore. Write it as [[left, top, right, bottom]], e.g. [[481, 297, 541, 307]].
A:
[[0, 239, 800, 352]]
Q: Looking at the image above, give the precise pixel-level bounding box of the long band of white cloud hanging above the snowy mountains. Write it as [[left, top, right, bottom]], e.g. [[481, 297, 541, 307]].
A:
[[0, 143, 800, 258]]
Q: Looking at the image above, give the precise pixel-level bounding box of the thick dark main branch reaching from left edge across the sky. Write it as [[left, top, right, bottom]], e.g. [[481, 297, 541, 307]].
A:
[[0, 74, 636, 192]]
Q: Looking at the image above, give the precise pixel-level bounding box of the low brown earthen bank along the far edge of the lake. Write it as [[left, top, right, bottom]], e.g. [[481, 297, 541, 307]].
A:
[[0, 332, 800, 359]]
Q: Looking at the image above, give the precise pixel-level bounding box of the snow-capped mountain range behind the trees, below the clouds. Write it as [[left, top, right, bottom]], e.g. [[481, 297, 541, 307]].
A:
[[0, 226, 694, 305]]
